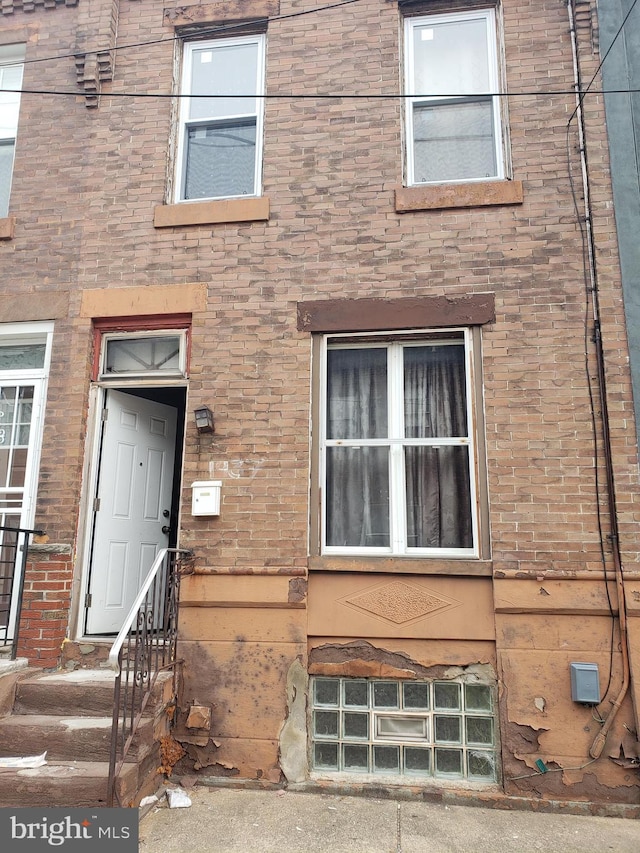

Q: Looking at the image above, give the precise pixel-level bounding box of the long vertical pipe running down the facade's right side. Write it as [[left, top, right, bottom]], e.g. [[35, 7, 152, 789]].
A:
[[567, 0, 638, 759]]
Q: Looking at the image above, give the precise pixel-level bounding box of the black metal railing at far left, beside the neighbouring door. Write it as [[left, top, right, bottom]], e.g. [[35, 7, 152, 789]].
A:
[[0, 525, 43, 660]]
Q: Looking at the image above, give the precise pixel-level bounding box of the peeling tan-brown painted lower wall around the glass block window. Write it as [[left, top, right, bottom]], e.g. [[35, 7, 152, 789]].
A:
[[170, 572, 640, 803]]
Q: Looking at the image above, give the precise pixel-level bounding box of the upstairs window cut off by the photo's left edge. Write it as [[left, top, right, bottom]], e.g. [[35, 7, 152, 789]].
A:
[[0, 45, 24, 217]]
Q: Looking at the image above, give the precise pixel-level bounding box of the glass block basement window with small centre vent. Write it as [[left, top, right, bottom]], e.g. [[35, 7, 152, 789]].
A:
[[311, 677, 497, 783]]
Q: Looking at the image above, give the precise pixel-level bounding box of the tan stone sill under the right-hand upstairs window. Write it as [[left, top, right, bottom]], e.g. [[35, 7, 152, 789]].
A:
[[396, 181, 523, 213]]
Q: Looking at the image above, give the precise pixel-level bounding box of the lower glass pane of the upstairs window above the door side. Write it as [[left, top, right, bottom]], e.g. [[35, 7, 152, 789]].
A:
[[184, 119, 256, 199]]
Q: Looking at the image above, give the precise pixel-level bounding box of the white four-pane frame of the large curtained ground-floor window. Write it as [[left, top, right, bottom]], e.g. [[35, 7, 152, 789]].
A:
[[319, 328, 480, 559]]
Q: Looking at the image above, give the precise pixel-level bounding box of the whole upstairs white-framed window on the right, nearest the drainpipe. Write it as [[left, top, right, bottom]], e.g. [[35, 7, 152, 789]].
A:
[[405, 9, 504, 186]]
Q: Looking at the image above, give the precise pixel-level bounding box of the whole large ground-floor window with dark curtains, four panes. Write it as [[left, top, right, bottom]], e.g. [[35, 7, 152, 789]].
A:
[[321, 330, 477, 556]]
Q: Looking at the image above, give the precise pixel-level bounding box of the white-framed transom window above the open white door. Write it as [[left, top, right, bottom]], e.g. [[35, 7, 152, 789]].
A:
[[100, 330, 186, 379]]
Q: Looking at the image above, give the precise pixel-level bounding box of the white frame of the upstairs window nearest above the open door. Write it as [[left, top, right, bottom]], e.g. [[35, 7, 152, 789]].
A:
[[174, 33, 266, 203]]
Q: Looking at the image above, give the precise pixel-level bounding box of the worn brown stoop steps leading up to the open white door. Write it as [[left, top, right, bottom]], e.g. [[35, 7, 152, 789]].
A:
[[0, 669, 170, 807]]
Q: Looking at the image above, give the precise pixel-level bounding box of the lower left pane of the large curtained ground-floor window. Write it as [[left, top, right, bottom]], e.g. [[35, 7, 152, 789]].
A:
[[327, 447, 389, 548]]
